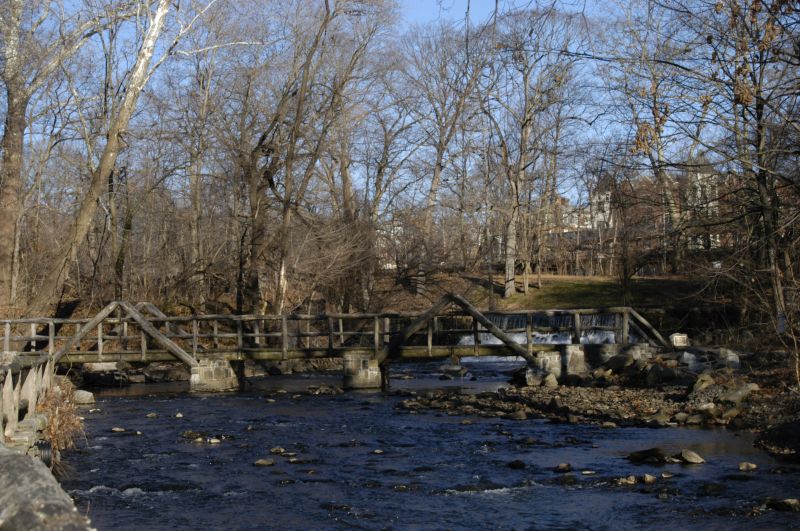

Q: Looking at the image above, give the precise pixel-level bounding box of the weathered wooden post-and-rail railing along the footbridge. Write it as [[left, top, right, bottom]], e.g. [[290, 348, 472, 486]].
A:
[[0, 307, 664, 363]]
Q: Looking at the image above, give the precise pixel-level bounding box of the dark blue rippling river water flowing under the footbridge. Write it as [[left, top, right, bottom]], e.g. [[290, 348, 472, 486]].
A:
[[63, 363, 800, 530]]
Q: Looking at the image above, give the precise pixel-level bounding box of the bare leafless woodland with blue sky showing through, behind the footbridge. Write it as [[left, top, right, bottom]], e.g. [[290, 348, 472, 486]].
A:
[[0, 0, 800, 370]]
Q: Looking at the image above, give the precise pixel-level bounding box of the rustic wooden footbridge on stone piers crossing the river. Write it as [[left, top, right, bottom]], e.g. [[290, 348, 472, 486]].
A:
[[0, 294, 668, 442]]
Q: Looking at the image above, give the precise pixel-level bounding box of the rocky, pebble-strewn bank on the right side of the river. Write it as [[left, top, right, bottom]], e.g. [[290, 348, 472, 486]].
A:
[[398, 352, 800, 460]]
